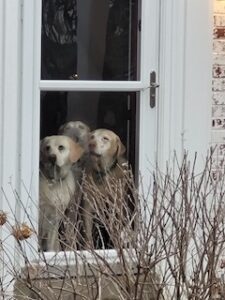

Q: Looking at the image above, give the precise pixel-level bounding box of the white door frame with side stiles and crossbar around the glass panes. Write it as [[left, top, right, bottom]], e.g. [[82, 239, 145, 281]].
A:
[[17, 0, 160, 260]]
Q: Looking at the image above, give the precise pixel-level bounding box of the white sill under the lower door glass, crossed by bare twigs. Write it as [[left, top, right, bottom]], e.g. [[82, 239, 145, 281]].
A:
[[21, 249, 137, 279]]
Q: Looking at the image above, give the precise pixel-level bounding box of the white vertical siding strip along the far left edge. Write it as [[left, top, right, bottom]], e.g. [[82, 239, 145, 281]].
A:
[[0, 0, 21, 291]]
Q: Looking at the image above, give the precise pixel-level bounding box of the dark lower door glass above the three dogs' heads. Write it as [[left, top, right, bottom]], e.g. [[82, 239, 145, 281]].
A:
[[40, 92, 138, 166]]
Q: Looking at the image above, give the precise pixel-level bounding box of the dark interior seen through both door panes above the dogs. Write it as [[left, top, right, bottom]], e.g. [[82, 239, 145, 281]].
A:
[[40, 0, 140, 166]]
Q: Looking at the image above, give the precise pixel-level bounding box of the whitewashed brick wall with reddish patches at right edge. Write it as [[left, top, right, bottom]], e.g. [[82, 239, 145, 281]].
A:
[[212, 0, 225, 176]]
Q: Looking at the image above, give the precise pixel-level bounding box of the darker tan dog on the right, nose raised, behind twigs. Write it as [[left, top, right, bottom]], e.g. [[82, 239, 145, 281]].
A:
[[83, 129, 127, 245]]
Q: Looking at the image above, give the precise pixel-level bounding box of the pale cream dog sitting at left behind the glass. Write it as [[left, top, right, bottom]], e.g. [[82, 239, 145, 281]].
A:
[[39, 135, 84, 251]]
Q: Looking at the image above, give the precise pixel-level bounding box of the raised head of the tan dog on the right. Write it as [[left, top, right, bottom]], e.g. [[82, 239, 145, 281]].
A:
[[89, 129, 126, 169]]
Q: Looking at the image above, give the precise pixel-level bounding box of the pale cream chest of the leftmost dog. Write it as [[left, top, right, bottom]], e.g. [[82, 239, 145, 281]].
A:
[[39, 173, 75, 210]]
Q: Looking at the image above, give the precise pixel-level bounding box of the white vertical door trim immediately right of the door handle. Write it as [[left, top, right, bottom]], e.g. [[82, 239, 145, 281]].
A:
[[158, 0, 186, 169]]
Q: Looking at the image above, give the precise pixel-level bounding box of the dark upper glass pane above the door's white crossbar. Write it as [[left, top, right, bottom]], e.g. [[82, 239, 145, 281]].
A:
[[41, 0, 140, 80]]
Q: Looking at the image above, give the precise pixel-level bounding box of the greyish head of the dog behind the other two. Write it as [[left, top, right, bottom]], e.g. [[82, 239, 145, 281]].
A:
[[58, 121, 90, 148]]
